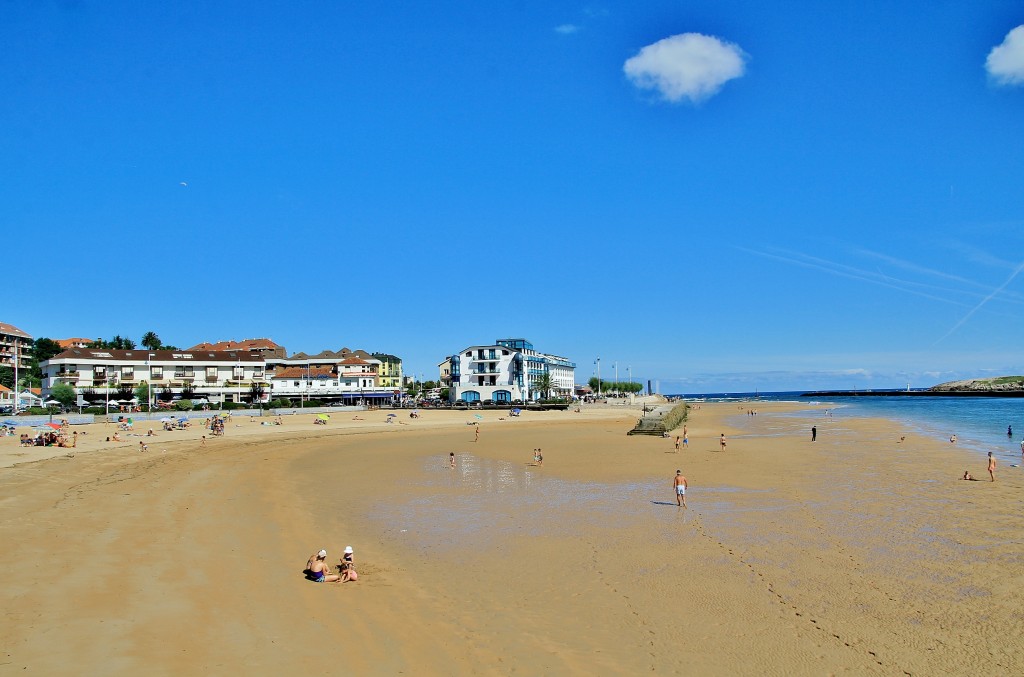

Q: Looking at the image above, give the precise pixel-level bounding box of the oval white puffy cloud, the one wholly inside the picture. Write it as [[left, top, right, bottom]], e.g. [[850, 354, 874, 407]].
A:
[[623, 33, 746, 102]]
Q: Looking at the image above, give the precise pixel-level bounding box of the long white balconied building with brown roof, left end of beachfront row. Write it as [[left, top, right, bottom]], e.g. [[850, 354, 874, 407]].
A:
[[40, 348, 269, 405]]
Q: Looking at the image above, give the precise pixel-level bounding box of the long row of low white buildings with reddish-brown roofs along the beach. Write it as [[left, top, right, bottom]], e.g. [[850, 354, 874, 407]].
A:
[[41, 339, 402, 405]]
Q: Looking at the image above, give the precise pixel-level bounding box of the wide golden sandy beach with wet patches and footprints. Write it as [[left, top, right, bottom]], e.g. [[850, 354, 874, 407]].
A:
[[0, 403, 1024, 675]]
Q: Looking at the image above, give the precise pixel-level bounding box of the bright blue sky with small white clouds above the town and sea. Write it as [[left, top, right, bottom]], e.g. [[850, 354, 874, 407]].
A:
[[0, 0, 1024, 392]]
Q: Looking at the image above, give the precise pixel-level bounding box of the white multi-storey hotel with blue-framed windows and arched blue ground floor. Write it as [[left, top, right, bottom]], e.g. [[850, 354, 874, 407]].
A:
[[441, 339, 575, 403]]
